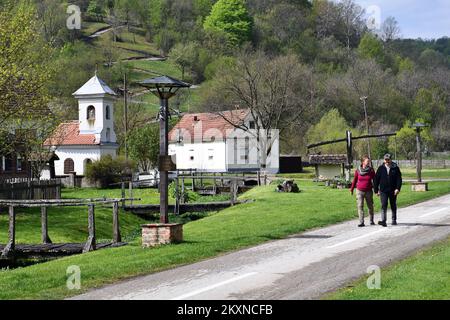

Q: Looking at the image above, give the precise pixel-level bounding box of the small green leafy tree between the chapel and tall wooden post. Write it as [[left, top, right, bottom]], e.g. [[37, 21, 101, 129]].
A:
[[128, 125, 159, 172]]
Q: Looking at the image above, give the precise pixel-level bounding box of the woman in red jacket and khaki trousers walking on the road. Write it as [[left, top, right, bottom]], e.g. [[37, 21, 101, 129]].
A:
[[350, 156, 375, 228]]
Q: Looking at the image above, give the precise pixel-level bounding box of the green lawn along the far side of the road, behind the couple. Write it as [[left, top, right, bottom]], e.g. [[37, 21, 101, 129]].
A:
[[0, 182, 450, 299]]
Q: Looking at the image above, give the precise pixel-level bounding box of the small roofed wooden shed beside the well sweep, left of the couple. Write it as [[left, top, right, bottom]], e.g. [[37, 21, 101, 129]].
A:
[[309, 154, 347, 180]]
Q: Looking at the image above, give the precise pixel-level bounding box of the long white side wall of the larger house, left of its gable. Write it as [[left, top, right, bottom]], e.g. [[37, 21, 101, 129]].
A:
[[169, 142, 227, 172]]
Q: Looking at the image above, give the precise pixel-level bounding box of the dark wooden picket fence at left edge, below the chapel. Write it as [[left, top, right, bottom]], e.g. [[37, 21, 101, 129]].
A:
[[0, 178, 61, 200]]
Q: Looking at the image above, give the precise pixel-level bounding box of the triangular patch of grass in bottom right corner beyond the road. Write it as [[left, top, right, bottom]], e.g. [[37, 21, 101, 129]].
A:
[[325, 238, 450, 300]]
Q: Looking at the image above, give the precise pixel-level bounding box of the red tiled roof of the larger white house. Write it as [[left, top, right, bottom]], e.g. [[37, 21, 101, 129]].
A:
[[169, 109, 249, 141]]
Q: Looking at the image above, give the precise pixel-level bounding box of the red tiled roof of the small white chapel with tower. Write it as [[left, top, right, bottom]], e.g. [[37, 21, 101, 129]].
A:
[[44, 121, 99, 146]]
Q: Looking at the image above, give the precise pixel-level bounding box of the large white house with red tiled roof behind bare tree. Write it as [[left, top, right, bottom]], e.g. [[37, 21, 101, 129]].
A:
[[169, 110, 279, 173]]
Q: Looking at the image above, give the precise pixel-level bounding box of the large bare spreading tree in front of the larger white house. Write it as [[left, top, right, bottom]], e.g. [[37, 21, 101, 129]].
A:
[[202, 52, 319, 168]]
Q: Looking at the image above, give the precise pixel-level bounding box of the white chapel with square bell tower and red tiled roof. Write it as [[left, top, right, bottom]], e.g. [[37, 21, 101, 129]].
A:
[[45, 75, 118, 176]]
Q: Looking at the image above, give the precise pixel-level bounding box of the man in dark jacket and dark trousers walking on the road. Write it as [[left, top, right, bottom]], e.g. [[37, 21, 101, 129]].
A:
[[374, 154, 403, 227]]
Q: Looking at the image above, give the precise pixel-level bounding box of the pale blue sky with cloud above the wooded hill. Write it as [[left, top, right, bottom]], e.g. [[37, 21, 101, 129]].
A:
[[355, 0, 450, 39]]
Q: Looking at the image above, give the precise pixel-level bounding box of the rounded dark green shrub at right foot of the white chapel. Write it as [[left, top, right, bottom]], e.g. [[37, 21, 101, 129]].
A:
[[86, 155, 135, 188]]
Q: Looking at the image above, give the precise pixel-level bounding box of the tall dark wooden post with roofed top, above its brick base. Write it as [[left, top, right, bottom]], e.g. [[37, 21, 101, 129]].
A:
[[139, 76, 190, 224]]
